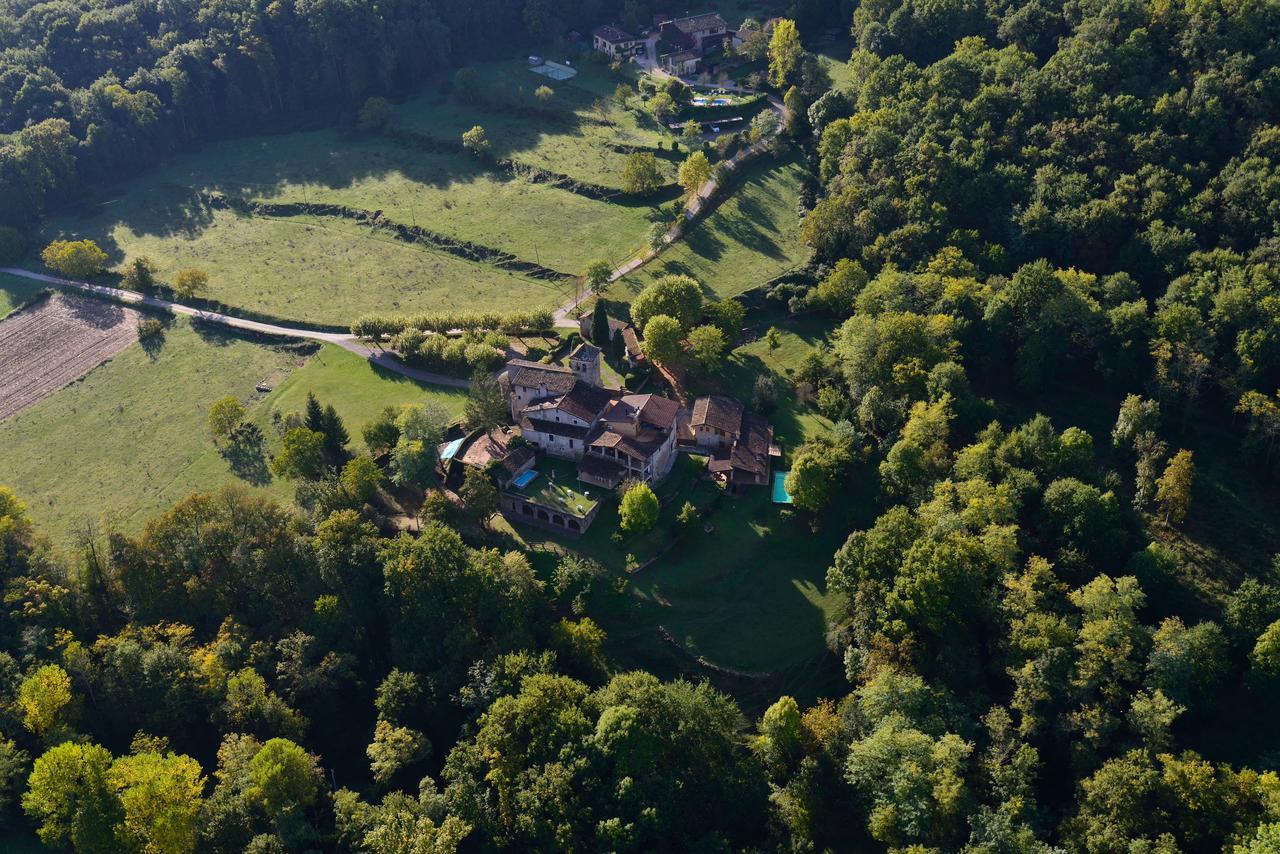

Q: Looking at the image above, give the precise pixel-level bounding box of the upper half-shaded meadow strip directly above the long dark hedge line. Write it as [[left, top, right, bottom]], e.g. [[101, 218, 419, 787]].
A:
[[47, 131, 654, 274]]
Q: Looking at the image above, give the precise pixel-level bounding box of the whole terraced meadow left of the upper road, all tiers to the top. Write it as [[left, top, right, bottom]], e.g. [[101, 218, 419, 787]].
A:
[[32, 60, 691, 325]]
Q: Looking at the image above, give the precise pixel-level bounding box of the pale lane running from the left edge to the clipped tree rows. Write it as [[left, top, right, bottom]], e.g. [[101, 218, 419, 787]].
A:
[[0, 266, 471, 388]]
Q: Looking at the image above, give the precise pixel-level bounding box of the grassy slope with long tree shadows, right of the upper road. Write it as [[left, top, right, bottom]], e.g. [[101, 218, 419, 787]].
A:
[[607, 152, 810, 301]]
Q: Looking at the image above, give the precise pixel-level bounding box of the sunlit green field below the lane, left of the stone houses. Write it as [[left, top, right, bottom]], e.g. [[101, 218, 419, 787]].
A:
[[0, 321, 462, 544]]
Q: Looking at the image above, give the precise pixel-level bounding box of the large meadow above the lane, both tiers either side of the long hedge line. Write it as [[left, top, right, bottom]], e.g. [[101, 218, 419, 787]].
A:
[[42, 123, 658, 325]]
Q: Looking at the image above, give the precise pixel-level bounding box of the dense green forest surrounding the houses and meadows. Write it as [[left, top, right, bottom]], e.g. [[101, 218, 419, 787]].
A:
[[0, 0, 1280, 854]]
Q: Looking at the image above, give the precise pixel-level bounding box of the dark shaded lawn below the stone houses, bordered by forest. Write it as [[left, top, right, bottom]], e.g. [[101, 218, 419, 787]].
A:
[[495, 455, 870, 680]]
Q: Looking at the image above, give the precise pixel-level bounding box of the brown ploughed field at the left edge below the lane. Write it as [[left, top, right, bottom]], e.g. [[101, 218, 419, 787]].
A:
[[0, 294, 140, 421]]
